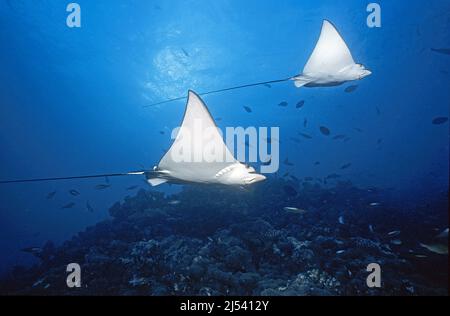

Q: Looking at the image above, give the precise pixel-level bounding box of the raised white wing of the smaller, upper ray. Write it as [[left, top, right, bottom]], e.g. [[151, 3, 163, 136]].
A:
[[303, 20, 355, 75]]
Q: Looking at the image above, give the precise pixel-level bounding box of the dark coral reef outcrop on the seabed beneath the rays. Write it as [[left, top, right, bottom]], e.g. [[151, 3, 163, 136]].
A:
[[0, 179, 448, 295]]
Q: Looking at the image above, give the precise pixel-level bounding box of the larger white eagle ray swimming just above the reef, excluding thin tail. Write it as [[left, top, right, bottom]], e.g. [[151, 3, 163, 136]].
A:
[[146, 91, 265, 186]]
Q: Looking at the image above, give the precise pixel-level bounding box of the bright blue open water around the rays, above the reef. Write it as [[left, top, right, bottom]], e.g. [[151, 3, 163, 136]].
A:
[[0, 0, 450, 294]]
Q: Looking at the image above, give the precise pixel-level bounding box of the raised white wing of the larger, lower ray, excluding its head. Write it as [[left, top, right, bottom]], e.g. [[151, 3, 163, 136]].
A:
[[157, 91, 238, 184]]
